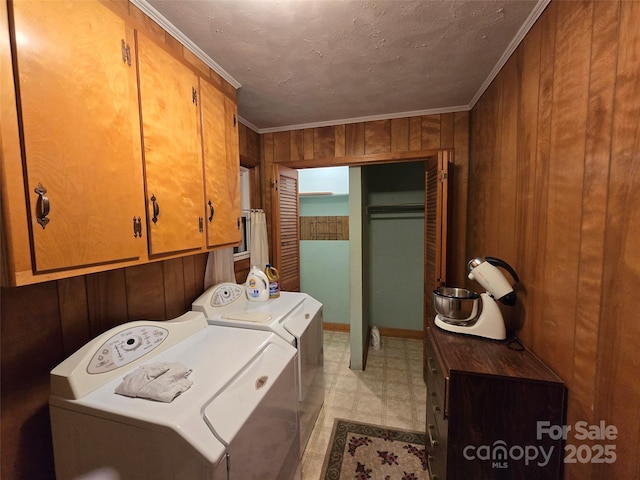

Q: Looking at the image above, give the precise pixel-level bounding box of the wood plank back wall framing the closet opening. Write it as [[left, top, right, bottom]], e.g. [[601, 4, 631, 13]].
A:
[[260, 112, 469, 285]]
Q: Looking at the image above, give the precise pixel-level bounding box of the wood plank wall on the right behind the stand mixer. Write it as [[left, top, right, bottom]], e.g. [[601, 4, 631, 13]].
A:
[[467, 1, 640, 480]]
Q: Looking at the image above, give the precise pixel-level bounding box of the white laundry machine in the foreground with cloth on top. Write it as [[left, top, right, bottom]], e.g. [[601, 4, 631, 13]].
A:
[[49, 312, 300, 480]]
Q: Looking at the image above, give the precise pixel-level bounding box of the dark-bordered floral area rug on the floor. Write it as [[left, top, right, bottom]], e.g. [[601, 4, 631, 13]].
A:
[[320, 418, 429, 480]]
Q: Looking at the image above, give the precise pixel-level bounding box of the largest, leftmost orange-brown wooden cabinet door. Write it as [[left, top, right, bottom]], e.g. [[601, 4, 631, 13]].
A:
[[11, 0, 146, 272]]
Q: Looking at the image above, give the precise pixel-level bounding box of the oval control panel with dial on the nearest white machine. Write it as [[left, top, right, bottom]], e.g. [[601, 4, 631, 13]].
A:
[[87, 325, 169, 374]]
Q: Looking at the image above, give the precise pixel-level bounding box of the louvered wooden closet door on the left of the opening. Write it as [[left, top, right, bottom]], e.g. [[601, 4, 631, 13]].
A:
[[271, 164, 300, 292]]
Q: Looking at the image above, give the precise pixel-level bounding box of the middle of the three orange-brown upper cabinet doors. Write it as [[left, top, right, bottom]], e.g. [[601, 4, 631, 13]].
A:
[[137, 32, 203, 255]]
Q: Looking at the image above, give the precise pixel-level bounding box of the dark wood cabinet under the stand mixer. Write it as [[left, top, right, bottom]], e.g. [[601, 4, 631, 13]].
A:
[[425, 325, 567, 480]]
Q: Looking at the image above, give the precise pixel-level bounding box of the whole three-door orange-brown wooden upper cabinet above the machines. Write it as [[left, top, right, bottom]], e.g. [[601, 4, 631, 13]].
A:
[[0, 0, 240, 286]]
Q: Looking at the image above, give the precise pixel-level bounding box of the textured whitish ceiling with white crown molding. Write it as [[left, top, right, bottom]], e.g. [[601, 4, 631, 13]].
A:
[[138, 0, 548, 132]]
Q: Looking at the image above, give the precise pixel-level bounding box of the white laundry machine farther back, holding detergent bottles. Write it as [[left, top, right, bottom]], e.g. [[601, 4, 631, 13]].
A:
[[192, 283, 324, 453]]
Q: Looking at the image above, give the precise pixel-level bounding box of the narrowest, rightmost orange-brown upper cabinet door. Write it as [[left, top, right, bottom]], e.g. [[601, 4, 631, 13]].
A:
[[200, 81, 241, 247]]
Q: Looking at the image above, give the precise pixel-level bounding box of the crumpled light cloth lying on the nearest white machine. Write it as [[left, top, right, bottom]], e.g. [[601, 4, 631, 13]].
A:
[[116, 362, 193, 403]]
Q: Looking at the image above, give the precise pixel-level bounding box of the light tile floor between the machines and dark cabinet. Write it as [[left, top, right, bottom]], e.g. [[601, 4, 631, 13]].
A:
[[302, 331, 427, 480]]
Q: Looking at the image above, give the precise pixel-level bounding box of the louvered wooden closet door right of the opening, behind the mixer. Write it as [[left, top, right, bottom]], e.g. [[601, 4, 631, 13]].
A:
[[423, 151, 452, 375]]
